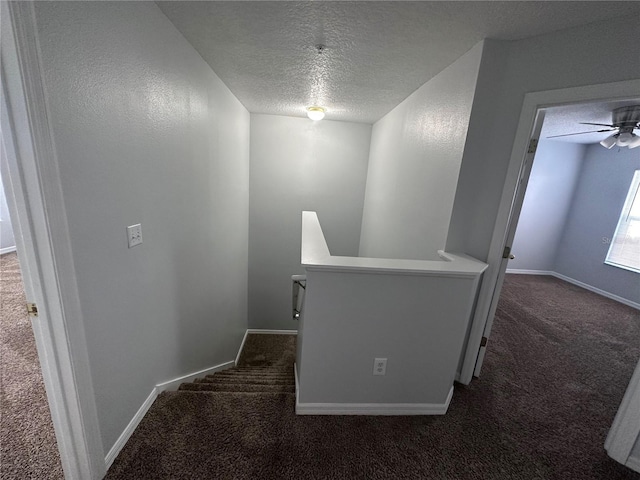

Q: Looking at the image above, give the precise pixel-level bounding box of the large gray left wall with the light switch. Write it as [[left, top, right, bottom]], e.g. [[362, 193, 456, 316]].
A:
[[36, 2, 249, 450]]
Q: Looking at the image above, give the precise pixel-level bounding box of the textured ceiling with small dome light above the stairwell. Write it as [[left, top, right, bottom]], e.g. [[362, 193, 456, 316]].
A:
[[157, 1, 640, 123]]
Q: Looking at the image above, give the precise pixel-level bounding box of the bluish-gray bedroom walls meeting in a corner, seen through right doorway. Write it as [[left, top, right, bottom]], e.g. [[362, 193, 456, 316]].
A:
[[509, 141, 640, 303]]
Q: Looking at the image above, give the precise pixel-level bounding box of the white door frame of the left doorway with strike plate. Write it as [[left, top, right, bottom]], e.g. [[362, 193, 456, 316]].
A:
[[0, 2, 106, 480]]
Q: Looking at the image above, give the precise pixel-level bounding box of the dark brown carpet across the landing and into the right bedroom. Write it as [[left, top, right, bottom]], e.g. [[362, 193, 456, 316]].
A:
[[107, 276, 640, 480]]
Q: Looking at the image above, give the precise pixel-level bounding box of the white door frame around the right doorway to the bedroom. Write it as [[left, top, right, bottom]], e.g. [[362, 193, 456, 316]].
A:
[[459, 79, 640, 384]]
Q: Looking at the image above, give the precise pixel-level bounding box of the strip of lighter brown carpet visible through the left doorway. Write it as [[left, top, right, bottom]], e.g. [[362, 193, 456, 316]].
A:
[[0, 253, 64, 480]]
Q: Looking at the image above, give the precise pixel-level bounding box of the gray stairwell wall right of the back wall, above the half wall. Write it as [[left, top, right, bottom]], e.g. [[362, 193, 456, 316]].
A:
[[358, 42, 483, 260]]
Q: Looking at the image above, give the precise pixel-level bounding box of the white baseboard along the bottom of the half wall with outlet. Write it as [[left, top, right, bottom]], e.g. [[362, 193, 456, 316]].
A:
[[296, 386, 453, 415]]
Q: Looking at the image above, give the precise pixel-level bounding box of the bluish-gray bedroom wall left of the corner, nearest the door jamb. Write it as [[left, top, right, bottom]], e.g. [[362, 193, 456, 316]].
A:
[[509, 140, 584, 271]]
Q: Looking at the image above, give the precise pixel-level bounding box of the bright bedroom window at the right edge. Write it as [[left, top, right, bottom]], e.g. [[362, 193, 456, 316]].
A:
[[604, 170, 640, 273]]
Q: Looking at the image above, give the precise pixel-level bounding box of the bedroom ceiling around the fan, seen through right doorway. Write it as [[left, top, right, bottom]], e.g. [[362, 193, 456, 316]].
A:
[[540, 97, 640, 144]]
